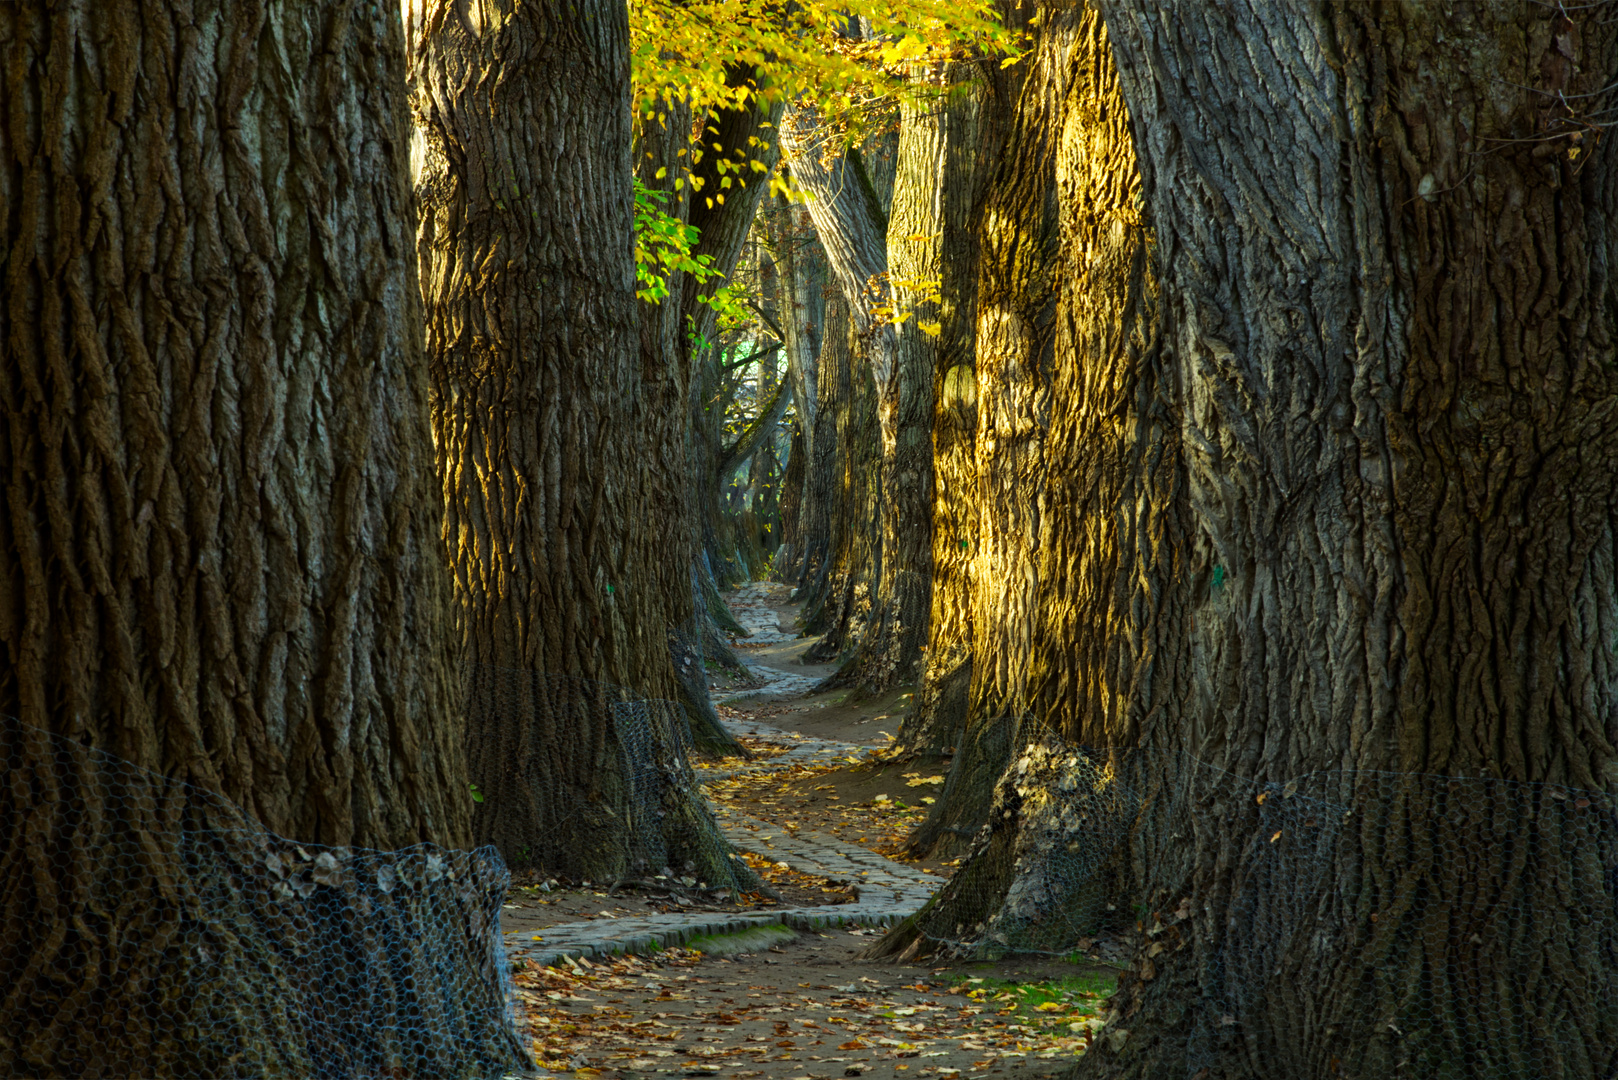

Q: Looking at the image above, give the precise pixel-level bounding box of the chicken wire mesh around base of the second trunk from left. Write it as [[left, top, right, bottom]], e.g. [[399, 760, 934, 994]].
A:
[[468, 665, 759, 889]]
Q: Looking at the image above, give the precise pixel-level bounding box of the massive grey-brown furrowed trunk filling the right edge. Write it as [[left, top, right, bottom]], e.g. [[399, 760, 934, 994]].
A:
[[1061, 3, 1618, 1077]]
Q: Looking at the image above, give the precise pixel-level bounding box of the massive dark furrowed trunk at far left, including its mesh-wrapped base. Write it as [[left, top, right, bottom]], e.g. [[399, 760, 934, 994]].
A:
[[0, 0, 526, 1077]]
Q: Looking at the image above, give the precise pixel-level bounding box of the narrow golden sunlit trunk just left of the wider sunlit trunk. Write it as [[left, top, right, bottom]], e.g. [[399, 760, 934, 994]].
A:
[[908, 5, 1080, 857]]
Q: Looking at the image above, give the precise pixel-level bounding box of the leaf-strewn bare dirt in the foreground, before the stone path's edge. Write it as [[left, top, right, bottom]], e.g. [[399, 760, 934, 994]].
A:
[[516, 931, 1112, 1080]]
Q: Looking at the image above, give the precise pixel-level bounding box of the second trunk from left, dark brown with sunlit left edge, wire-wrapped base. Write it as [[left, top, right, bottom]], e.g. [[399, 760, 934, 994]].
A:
[[411, 0, 741, 886]]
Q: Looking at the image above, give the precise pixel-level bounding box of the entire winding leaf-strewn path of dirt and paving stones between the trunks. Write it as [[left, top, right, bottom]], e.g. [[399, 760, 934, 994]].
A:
[[506, 583, 1113, 1080]]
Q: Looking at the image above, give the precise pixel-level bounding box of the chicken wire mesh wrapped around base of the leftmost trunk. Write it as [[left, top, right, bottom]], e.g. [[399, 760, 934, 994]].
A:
[[0, 717, 532, 1080]]
